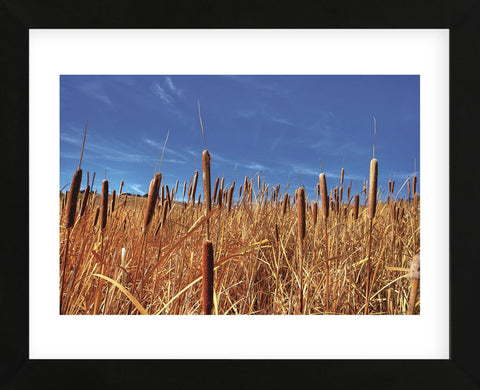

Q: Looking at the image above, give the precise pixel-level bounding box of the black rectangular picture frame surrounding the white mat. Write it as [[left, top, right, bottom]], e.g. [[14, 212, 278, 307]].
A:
[[0, 0, 480, 389]]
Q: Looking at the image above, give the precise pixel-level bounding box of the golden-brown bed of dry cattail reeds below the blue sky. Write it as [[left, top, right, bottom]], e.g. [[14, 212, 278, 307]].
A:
[[59, 169, 420, 315]]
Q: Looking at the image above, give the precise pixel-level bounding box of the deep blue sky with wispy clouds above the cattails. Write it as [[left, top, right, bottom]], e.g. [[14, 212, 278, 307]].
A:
[[60, 75, 420, 198]]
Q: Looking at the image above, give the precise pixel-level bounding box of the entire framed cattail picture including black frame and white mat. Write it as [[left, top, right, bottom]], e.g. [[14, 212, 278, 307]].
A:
[[5, 2, 479, 388]]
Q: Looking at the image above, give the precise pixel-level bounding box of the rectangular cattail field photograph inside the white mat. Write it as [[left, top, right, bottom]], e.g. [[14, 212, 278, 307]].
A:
[[56, 74, 422, 316]]
